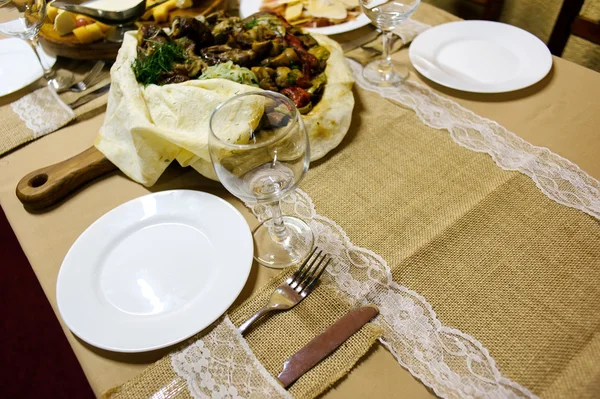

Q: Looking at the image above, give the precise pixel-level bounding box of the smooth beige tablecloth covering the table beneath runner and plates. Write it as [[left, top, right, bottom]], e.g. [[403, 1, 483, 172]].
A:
[[0, 3, 600, 398]]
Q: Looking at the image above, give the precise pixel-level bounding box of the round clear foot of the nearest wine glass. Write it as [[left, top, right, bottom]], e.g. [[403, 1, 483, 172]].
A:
[[252, 216, 314, 269]]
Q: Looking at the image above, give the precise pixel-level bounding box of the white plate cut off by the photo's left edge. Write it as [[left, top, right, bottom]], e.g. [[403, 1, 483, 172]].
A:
[[0, 38, 56, 97]]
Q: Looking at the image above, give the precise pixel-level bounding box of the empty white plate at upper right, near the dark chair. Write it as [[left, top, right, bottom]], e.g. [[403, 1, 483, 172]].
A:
[[409, 21, 552, 93]]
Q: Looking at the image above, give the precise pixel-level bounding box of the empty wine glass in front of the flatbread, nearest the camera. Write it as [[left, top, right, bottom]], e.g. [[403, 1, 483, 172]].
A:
[[209, 91, 314, 269]]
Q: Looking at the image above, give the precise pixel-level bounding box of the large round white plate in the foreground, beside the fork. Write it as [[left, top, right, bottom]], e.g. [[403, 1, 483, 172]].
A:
[[56, 190, 253, 352]]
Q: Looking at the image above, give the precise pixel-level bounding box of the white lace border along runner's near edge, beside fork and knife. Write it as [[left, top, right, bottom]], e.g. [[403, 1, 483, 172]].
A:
[[246, 189, 535, 398]]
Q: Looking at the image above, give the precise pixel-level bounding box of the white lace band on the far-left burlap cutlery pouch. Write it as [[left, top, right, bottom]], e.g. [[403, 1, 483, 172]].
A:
[[10, 87, 75, 139]]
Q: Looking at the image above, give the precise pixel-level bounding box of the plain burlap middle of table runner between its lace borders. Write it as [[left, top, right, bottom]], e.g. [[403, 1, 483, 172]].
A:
[[292, 83, 600, 398]]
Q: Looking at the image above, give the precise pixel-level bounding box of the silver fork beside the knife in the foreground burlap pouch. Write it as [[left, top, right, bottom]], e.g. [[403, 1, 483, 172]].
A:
[[238, 248, 331, 335]]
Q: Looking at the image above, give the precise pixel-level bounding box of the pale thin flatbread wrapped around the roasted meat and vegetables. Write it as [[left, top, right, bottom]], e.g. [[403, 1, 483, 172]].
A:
[[95, 32, 354, 187]]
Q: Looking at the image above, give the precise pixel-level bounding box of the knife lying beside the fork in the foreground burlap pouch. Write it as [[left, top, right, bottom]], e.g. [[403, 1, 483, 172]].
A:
[[277, 305, 379, 388]]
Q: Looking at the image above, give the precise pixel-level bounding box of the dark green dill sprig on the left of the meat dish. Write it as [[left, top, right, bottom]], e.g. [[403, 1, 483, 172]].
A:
[[131, 40, 187, 86]]
